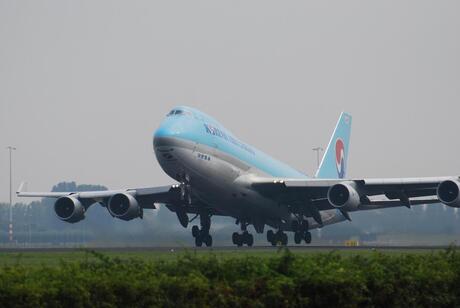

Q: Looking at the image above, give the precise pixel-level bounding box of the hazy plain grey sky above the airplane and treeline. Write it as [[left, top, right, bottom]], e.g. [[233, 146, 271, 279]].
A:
[[0, 0, 460, 201]]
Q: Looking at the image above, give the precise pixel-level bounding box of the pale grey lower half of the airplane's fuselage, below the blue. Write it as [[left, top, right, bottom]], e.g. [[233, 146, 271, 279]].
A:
[[154, 136, 342, 231]]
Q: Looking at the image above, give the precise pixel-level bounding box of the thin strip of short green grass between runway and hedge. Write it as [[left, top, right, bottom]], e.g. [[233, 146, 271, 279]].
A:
[[0, 247, 443, 266]]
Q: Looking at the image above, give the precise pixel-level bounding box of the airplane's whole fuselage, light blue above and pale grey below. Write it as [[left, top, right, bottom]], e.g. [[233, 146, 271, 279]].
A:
[[153, 108, 342, 231]]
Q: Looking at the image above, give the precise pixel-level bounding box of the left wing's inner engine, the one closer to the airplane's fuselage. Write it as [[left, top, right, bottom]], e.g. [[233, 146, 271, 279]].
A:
[[107, 193, 142, 220]]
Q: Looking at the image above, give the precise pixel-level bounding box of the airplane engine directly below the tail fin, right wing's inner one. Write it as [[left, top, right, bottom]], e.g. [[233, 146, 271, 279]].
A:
[[327, 183, 361, 211]]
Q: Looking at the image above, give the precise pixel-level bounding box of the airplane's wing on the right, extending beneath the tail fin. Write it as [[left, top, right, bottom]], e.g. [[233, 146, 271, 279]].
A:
[[251, 177, 454, 219]]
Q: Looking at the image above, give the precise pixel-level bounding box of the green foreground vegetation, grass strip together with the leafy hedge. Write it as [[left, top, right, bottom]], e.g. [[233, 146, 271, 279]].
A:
[[0, 247, 460, 307]]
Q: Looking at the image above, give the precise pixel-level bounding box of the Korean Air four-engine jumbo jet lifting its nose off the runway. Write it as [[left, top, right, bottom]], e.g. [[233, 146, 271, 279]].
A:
[[17, 106, 460, 247]]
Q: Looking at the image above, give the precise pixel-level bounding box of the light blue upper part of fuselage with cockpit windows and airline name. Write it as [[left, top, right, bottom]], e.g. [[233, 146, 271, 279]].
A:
[[154, 106, 308, 179]]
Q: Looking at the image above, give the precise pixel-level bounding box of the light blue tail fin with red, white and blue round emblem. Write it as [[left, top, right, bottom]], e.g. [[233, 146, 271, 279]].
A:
[[316, 112, 352, 179]]
